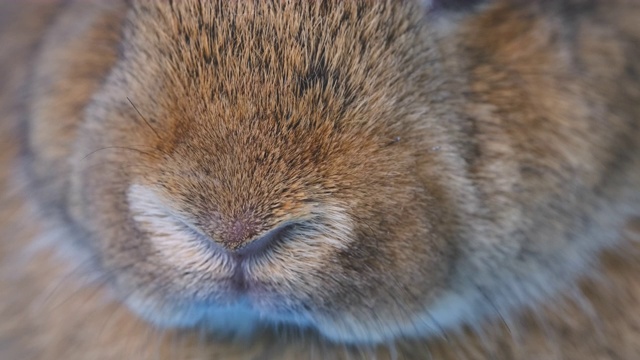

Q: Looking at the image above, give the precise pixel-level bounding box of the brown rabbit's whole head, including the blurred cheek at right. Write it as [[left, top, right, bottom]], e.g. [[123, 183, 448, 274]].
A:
[[31, 0, 638, 343]]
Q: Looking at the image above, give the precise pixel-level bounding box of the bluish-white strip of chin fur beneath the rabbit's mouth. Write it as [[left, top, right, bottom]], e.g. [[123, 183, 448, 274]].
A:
[[120, 296, 442, 345]]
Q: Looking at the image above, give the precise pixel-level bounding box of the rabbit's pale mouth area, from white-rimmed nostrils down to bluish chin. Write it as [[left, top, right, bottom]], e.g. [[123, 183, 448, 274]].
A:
[[124, 185, 392, 338]]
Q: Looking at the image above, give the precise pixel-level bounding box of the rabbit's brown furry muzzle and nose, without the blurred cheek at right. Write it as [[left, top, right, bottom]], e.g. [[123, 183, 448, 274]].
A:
[[63, 2, 464, 342]]
